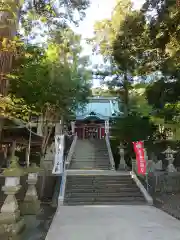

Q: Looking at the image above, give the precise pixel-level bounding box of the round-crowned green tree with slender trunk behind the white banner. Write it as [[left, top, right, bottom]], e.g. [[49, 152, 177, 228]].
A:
[[10, 29, 90, 154]]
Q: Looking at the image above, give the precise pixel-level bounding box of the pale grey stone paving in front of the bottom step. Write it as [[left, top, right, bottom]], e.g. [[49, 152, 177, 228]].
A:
[[46, 206, 180, 240]]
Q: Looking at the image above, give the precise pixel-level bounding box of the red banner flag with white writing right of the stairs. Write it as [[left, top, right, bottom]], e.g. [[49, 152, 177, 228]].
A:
[[133, 141, 146, 175]]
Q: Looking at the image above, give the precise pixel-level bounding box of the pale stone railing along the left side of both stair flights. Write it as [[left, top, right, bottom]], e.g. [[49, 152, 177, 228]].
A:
[[58, 135, 77, 205]]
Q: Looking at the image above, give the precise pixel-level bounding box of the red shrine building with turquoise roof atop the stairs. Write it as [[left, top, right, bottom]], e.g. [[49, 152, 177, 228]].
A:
[[73, 96, 123, 139]]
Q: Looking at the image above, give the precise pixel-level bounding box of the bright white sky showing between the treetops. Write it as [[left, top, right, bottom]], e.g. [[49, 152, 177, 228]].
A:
[[71, 0, 144, 87]]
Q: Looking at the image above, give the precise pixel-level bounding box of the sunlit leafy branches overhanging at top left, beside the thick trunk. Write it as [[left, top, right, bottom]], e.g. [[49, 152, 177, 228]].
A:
[[19, 0, 90, 38]]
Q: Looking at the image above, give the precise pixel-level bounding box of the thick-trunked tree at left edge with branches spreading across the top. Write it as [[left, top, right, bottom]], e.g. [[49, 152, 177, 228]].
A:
[[0, 0, 89, 141]]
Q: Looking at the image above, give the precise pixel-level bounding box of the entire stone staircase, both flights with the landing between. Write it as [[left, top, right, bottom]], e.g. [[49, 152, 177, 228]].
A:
[[63, 139, 146, 206]]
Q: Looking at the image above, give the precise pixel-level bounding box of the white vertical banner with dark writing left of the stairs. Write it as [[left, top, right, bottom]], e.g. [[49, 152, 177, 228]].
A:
[[52, 135, 64, 175]]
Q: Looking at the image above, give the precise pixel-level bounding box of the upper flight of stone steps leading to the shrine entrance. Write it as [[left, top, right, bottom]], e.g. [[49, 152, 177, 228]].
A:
[[69, 139, 111, 170]]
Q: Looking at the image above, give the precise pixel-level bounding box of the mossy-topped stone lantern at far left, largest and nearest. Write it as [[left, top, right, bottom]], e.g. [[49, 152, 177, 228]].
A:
[[0, 156, 25, 236]]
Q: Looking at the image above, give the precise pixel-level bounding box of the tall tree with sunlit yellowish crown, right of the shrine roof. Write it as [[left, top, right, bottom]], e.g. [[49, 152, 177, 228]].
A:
[[92, 0, 147, 115]]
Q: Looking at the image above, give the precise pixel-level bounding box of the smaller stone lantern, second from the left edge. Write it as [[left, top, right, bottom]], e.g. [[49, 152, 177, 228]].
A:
[[21, 164, 40, 215]]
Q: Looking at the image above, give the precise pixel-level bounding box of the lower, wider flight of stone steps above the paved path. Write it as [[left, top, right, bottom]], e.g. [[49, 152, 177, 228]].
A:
[[64, 174, 146, 206]]
